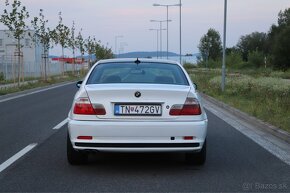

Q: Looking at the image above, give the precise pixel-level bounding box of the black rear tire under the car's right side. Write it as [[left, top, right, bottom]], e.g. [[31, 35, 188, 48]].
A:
[[185, 140, 206, 165]]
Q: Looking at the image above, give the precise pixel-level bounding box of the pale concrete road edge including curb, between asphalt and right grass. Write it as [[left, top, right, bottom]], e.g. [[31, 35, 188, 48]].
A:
[[201, 94, 290, 165]]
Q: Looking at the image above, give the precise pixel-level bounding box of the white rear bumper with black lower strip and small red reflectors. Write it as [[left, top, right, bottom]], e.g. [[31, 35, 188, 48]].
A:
[[68, 120, 207, 152]]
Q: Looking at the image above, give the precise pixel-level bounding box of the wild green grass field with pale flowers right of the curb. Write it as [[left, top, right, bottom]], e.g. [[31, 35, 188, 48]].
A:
[[188, 69, 290, 132]]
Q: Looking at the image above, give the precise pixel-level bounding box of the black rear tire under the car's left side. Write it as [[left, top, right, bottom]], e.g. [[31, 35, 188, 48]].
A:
[[66, 135, 88, 165]]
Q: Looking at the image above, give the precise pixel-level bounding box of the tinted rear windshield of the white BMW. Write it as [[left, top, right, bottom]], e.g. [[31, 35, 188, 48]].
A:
[[87, 62, 189, 85]]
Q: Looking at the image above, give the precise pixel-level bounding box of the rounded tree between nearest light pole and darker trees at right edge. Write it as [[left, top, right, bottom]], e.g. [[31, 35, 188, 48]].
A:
[[237, 32, 267, 61]]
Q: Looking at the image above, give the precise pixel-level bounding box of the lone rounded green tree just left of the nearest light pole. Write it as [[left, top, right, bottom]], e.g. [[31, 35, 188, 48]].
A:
[[198, 28, 222, 61]]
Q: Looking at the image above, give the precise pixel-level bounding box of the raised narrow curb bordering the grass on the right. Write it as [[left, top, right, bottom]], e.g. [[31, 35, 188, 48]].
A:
[[199, 93, 290, 144]]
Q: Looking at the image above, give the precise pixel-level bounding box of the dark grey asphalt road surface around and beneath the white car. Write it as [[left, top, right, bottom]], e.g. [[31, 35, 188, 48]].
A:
[[0, 85, 290, 192]]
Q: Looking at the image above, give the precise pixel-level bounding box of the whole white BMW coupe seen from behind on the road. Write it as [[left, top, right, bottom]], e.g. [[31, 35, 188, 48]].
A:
[[67, 59, 208, 165]]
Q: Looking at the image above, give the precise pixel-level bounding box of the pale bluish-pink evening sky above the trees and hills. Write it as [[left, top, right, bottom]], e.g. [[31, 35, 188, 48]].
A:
[[0, 0, 290, 54]]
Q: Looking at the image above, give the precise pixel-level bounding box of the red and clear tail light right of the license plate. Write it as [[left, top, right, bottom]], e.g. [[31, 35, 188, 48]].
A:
[[169, 97, 201, 116]]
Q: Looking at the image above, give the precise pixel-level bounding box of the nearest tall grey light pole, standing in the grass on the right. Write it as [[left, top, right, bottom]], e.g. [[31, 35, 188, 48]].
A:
[[221, 0, 227, 91]]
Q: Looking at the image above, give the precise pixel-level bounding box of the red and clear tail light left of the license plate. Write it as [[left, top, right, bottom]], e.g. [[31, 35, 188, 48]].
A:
[[74, 97, 106, 115]]
